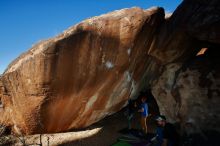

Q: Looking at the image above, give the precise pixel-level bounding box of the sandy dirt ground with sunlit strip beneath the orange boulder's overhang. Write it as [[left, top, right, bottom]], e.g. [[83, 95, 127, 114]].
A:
[[2, 109, 156, 146]]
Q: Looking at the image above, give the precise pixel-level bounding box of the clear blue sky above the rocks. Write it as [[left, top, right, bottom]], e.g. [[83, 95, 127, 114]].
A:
[[0, 0, 182, 74]]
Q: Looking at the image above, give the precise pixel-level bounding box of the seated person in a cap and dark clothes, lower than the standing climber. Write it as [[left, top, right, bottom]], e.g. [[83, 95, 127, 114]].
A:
[[156, 115, 179, 146]]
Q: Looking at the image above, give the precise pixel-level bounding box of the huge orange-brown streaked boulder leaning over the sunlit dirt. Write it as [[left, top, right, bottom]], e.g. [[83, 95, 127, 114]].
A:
[[0, 8, 164, 134]]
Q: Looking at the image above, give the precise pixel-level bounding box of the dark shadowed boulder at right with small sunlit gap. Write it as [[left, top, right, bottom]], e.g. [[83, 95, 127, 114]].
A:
[[149, 0, 220, 132]]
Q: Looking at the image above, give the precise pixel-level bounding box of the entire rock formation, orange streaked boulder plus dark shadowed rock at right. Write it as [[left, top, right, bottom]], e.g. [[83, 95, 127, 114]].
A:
[[0, 0, 220, 134]]
